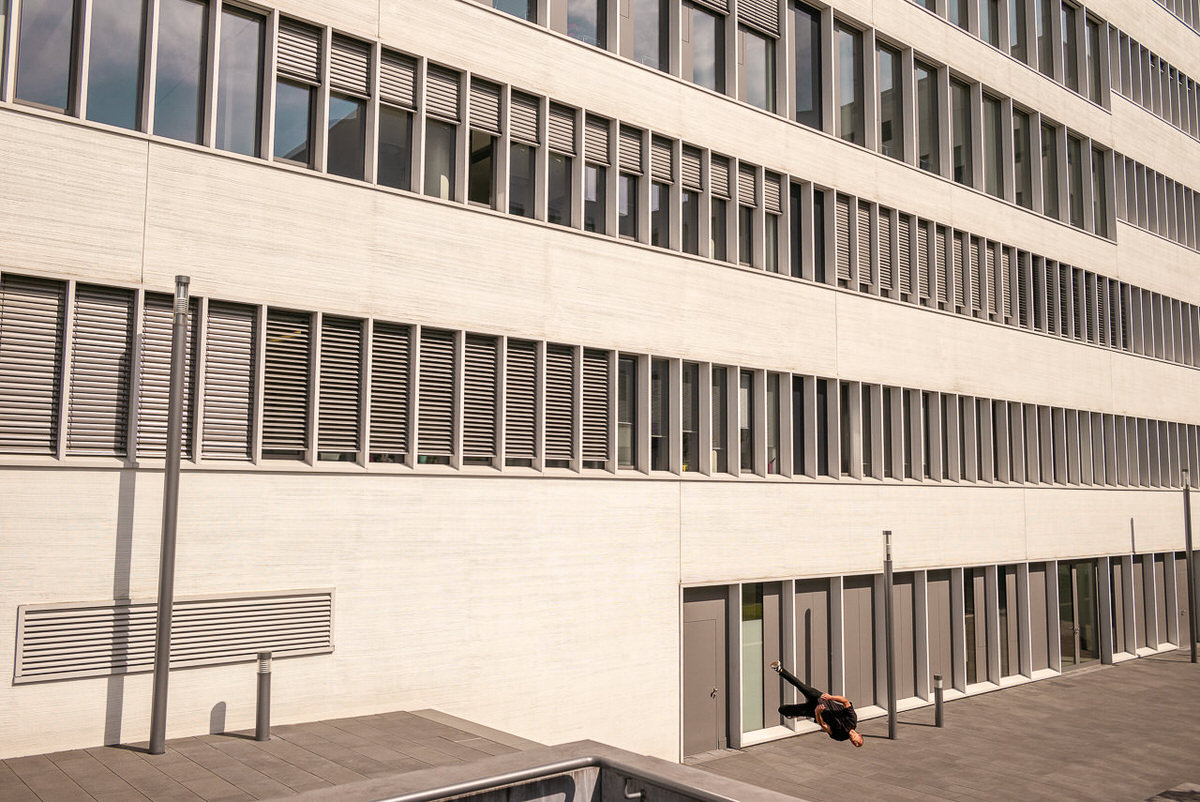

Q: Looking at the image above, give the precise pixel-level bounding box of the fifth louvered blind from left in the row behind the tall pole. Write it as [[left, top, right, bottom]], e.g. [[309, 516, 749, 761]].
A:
[[263, 309, 312, 456]]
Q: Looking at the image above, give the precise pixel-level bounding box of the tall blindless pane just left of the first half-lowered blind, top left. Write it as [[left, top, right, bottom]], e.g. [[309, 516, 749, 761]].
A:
[[216, 6, 264, 156]]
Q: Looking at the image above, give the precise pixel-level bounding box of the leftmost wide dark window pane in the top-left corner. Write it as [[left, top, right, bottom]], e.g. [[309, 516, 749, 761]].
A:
[[15, 0, 76, 110]]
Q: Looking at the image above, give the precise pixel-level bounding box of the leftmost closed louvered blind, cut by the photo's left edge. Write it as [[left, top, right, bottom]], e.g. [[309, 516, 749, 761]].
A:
[[0, 275, 66, 454]]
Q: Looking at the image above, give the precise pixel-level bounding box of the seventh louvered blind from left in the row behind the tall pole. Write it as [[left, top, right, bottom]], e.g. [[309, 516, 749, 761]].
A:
[[371, 323, 412, 462]]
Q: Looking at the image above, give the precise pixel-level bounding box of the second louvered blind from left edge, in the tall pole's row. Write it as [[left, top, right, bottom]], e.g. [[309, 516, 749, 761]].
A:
[[67, 285, 133, 456]]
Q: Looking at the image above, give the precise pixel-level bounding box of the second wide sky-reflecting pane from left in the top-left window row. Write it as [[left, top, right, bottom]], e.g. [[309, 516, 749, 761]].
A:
[[88, 0, 145, 128]]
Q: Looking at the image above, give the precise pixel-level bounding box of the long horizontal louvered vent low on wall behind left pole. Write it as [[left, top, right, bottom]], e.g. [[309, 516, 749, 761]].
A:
[[13, 589, 334, 684]]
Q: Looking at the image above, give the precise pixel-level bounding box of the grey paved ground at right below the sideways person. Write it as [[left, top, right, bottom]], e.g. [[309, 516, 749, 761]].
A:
[[697, 651, 1200, 802]]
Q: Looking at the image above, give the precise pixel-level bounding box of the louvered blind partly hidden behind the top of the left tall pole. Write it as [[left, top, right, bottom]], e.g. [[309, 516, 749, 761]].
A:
[[137, 293, 199, 457]]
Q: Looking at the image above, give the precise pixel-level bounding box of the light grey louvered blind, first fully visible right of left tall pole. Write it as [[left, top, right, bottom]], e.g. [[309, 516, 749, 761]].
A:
[[200, 301, 258, 460]]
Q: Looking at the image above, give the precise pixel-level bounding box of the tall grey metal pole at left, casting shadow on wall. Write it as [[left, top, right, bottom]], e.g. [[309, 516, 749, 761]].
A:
[[150, 276, 190, 755]]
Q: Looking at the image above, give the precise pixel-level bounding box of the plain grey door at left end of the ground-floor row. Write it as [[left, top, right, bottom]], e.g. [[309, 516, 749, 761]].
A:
[[683, 587, 728, 756]]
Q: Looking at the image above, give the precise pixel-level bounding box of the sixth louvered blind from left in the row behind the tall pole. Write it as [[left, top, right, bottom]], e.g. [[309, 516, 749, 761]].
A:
[[317, 316, 362, 461]]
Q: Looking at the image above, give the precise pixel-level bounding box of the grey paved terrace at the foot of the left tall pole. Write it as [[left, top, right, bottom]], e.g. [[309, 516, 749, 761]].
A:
[[0, 711, 539, 802]]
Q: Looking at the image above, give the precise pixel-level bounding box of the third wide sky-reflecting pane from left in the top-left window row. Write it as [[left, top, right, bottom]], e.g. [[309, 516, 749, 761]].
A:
[[154, 0, 208, 142]]
